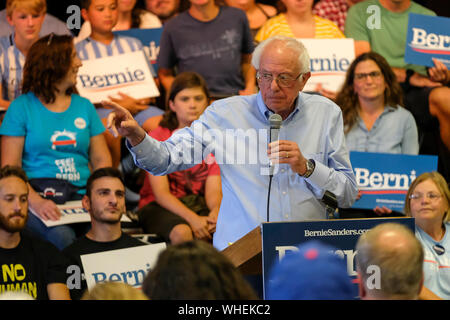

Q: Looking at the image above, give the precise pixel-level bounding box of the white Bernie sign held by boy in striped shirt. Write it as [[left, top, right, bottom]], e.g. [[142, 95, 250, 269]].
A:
[[76, 51, 159, 103]]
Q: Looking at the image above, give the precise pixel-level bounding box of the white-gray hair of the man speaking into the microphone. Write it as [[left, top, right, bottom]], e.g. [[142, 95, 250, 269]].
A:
[[252, 36, 310, 74]]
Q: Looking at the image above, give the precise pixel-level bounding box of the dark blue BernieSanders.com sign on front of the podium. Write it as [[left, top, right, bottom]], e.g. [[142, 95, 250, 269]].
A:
[[261, 218, 415, 297]]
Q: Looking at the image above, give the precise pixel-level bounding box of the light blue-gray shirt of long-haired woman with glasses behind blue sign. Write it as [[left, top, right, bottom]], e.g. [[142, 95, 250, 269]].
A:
[[346, 106, 419, 155]]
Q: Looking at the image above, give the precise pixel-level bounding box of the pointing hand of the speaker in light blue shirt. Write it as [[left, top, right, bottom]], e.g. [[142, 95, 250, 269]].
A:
[[102, 101, 146, 146]]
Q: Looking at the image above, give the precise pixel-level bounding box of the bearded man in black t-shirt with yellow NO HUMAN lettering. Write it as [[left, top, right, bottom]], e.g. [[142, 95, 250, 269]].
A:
[[0, 166, 70, 300]]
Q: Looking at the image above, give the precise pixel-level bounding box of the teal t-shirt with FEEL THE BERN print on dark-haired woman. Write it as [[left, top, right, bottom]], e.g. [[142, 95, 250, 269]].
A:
[[0, 93, 105, 187]]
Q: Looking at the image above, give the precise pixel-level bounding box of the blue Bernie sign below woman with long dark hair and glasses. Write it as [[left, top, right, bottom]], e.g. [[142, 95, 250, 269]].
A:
[[350, 151, 437, 212]]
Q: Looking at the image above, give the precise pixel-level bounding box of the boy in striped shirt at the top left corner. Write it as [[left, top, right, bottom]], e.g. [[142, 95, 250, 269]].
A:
[[0, 0, 47, 109]]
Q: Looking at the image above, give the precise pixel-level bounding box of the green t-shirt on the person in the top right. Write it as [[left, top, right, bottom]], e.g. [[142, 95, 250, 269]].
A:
[[345, 0, 436, 75]]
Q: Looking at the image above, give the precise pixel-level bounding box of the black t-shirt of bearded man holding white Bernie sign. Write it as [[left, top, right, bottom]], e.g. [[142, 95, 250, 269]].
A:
[[63, 233, 146, 300]]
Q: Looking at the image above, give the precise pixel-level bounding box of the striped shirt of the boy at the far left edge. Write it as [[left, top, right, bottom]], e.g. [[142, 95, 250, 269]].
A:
[[0, 34, 25, 101]]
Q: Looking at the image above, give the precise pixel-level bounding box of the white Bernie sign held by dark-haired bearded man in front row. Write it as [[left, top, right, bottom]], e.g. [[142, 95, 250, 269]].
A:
[[81, 242, 166, 290]]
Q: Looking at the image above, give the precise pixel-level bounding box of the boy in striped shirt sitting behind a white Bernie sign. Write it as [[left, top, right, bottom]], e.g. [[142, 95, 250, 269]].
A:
[[75, 0, 163, 167]]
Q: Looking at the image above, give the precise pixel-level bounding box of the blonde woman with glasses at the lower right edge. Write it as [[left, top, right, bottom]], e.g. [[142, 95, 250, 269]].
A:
[[404, 172, 450, 300]]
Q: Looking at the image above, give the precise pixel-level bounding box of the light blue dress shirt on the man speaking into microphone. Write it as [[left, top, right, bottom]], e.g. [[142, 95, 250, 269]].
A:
[[128, 93, 357, 250]]
